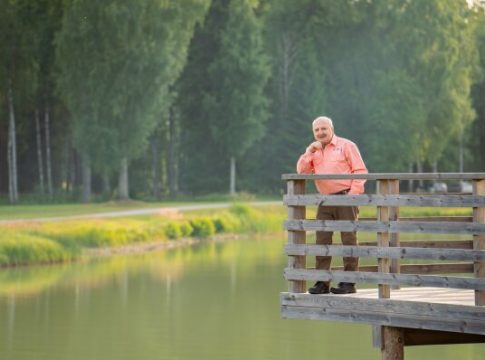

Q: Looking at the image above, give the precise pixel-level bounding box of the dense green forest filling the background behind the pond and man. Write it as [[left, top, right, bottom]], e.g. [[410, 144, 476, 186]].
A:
[[0, 0, 485, 204]]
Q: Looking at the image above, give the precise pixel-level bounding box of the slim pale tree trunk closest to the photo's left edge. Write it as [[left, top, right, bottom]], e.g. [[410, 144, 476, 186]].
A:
[[7, 80, 18, 204]]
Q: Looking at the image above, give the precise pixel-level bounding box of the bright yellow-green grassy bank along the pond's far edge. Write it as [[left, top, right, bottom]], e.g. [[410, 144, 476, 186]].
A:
[[0, 204, 285, 266]]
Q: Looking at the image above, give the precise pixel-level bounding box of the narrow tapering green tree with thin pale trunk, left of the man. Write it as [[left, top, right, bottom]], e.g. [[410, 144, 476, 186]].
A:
[[203, 0, 270, 194]]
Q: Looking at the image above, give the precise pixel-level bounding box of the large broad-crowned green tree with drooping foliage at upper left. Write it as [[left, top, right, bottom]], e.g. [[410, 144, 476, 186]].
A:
[[58, 0, 207, 199]]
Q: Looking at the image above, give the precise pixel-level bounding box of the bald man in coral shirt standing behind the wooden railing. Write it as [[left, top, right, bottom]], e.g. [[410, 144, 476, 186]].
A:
[[296, 116, 367, 294]]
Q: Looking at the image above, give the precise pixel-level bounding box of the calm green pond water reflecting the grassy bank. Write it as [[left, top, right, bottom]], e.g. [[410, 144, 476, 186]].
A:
[[0, 234, 485, 360]]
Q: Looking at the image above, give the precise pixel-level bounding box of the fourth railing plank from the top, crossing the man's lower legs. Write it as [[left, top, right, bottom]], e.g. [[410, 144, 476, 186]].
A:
[[285, 244, 485, 261]]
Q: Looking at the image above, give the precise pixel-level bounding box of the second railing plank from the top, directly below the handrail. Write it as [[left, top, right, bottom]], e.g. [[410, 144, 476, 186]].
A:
[[283, 194, 485, 207]]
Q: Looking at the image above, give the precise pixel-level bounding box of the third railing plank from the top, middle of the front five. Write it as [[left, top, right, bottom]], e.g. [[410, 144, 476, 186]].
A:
[[285, 220, 485, 235]]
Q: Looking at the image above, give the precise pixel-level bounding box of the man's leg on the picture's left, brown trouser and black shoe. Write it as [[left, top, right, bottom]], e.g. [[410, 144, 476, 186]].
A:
[[308, 206, 335, 294]]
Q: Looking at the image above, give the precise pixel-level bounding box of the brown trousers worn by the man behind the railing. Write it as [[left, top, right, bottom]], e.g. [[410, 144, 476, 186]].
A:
[[315, 206, 359, 284]]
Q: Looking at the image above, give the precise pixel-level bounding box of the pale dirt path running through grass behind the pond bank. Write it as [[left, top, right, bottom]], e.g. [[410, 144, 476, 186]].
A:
[[0, 201, 282, 224]]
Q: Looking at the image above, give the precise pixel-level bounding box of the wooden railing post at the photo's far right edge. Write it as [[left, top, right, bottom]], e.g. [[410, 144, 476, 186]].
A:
[[473, 180, 485, 306]]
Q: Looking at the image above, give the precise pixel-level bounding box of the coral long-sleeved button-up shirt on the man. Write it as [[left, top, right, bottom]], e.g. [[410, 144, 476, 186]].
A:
[[296, 134, 367, 194]]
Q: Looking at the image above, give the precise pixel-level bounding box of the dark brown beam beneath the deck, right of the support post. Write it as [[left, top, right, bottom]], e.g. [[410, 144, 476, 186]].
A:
[[404, 329, 485, 346]]
